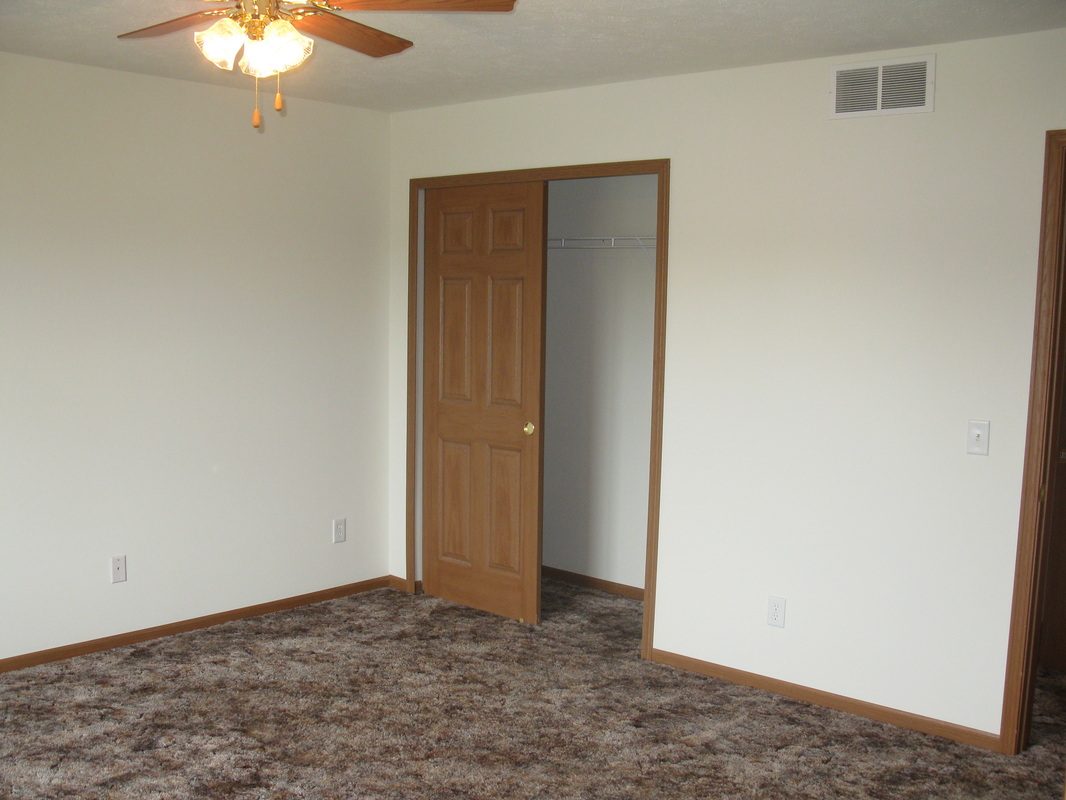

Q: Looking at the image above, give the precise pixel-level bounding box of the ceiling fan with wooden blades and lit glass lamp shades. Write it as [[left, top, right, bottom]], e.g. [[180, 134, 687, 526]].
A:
[[118, 0, 515, 128]]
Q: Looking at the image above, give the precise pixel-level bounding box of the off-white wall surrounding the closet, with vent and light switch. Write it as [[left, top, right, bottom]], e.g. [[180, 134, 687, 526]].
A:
[[390, 31, 1066, 732]]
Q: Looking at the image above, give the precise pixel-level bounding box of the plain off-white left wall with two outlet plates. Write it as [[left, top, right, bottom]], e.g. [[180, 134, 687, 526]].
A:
[[0, 53, 396, 657]]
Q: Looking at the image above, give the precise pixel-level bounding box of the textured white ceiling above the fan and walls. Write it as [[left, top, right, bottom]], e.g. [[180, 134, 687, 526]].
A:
[[0, 0, 1066, 111]]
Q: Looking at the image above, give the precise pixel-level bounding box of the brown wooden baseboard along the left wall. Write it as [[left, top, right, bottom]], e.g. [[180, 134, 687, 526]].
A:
[[0, 575, 406, 672]]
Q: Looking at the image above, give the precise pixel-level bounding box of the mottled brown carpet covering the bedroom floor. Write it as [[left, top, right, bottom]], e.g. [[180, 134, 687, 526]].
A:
[[0, 582, 1066, 800]]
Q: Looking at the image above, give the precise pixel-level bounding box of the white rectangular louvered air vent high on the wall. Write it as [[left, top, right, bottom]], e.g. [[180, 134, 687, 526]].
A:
[[829, 55, 936, 118]]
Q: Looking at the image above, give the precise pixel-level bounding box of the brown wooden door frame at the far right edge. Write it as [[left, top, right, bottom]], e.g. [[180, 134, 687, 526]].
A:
[[999, 130, 1066, 754]]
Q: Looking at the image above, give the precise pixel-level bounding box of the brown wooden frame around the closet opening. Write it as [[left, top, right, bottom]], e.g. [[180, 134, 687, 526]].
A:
[[402, 159, 669, 658]]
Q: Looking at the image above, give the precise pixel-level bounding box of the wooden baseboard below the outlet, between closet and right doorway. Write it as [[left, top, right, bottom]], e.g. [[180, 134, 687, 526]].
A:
[[650, 650, 1004, 753]]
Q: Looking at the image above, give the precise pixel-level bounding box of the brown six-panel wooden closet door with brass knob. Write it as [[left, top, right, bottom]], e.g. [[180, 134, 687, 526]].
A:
[[422, 181, 547, 623]]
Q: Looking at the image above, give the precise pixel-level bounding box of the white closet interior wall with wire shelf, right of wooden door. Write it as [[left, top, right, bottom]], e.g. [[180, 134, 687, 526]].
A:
[[543, 175, 658, 589]]
